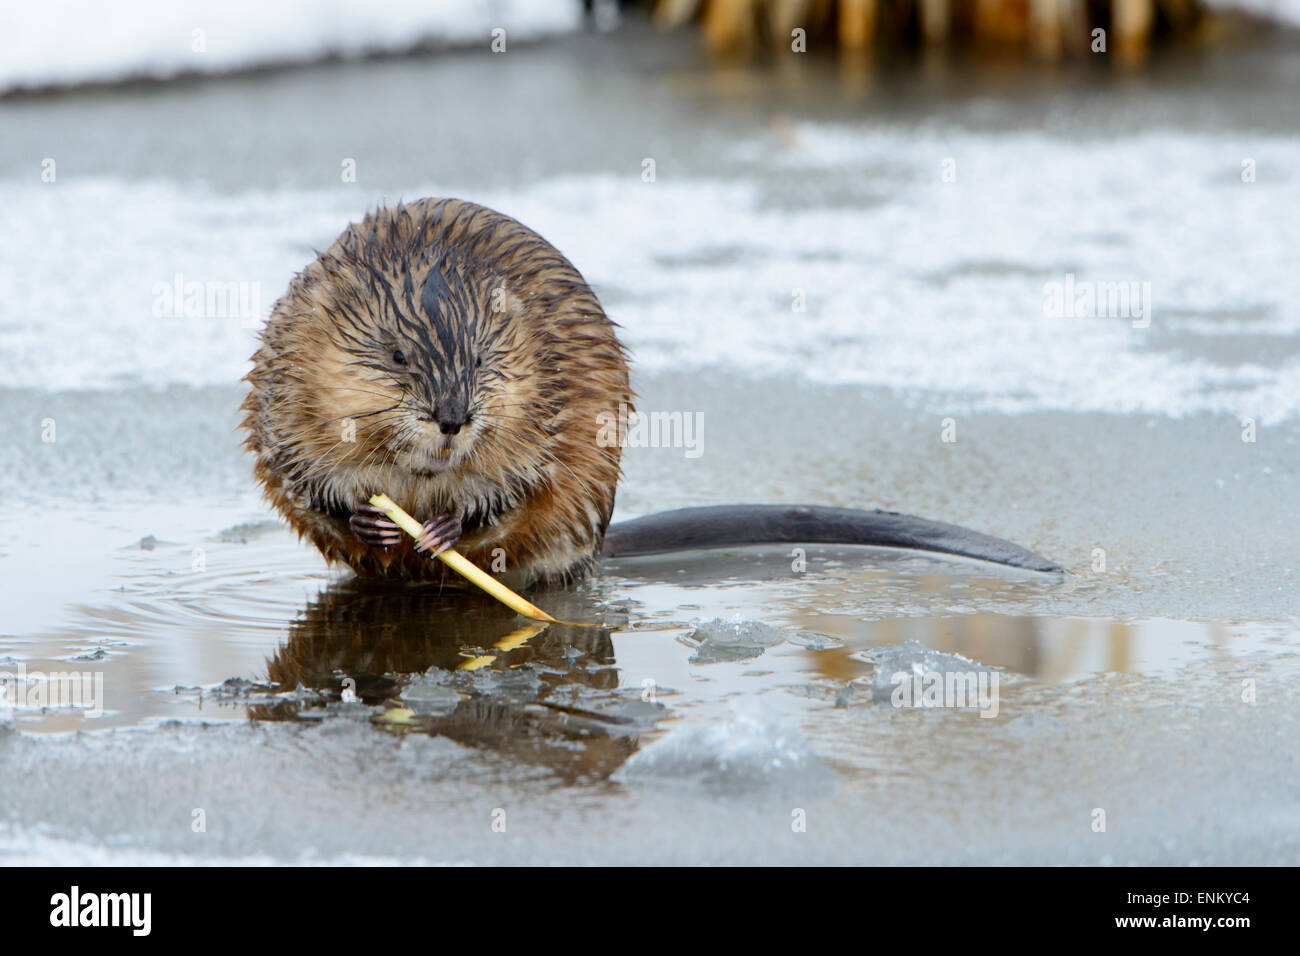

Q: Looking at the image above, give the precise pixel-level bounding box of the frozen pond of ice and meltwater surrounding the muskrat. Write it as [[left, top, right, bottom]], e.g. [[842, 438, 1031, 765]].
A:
[[0, 30, 1300, 864]]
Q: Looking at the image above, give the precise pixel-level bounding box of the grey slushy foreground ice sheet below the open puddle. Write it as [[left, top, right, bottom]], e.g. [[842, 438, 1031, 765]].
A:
[[0, 650, 1300, 865]]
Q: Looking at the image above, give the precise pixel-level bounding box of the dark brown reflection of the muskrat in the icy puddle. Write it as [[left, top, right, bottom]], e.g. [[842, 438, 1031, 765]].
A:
[[248, 579, 637, 779]]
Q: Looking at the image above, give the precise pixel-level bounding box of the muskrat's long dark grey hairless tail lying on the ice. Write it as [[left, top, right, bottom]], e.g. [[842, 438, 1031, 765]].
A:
[[603, 505, 1061, 572]]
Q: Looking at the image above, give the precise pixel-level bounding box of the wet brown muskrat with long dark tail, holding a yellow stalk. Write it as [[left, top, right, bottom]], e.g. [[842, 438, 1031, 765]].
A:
[[242, 199, 1058, 587]]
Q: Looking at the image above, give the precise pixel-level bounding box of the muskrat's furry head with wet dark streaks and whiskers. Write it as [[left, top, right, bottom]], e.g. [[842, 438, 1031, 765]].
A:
[[292, 250, 546, 486]]
